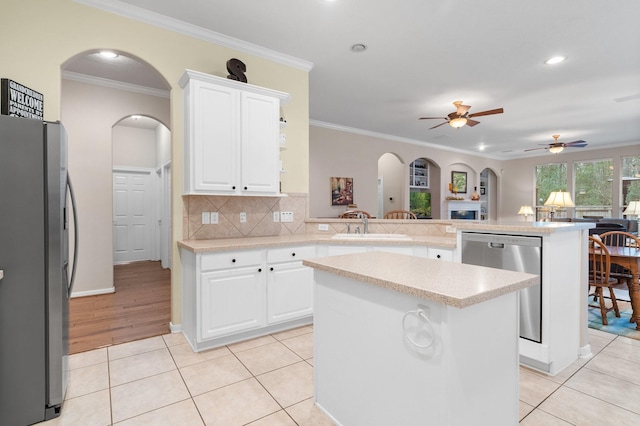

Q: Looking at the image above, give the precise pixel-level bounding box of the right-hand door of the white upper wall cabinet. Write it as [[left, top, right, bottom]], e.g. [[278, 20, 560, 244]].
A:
[[240, 92, 280, 194]]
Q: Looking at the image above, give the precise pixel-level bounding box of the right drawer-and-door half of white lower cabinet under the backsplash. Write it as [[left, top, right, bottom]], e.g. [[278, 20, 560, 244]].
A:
[[267, 246, 316, 324]]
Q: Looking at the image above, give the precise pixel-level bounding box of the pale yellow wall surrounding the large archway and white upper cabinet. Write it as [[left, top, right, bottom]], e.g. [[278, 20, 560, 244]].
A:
[[0, 0, 309, 324]]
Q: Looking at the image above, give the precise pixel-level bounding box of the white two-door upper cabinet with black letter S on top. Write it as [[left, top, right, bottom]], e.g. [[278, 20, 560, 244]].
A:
[[179, 70, 289, 195]]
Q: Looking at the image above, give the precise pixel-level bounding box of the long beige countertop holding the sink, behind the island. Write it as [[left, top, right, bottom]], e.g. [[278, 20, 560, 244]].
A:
[[178, 234, 456, 253]]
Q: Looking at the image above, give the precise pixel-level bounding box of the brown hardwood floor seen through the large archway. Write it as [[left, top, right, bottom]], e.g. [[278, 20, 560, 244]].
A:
[[69, 261, 171, 354]]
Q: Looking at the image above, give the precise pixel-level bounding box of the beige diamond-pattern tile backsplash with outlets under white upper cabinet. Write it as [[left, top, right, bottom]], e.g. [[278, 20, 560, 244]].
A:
[[182, 194, 307, 240]]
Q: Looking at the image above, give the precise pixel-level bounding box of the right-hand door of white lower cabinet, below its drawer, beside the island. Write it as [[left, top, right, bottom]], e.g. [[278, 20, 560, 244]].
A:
[[267, 262, 313, 324]]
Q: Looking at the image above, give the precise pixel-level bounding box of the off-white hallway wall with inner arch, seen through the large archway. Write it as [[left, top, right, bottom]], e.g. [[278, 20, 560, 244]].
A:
[[61, 80, 170, 294]]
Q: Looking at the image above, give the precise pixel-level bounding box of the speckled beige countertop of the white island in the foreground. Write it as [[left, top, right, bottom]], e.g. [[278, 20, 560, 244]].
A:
[[303, 252, 540, 308]]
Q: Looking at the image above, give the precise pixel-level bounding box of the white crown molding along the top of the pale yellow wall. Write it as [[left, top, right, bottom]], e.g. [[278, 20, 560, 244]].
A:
[[74, 0, 313, 72]]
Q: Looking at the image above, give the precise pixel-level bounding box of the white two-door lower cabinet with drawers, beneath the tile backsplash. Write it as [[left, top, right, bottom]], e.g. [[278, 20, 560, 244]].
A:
[[181, 246, 316, 352]]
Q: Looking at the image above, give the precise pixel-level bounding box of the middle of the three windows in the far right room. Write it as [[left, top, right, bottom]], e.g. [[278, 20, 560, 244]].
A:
[[573, 159, 613, 217]]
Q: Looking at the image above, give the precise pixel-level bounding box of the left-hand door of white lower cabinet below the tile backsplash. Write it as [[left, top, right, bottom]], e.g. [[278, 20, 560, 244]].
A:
[[198, 265, 265, 340]]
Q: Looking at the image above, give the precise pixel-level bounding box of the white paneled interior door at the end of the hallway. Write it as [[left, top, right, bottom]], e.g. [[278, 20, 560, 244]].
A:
[[113, 170, 153, 263]]
